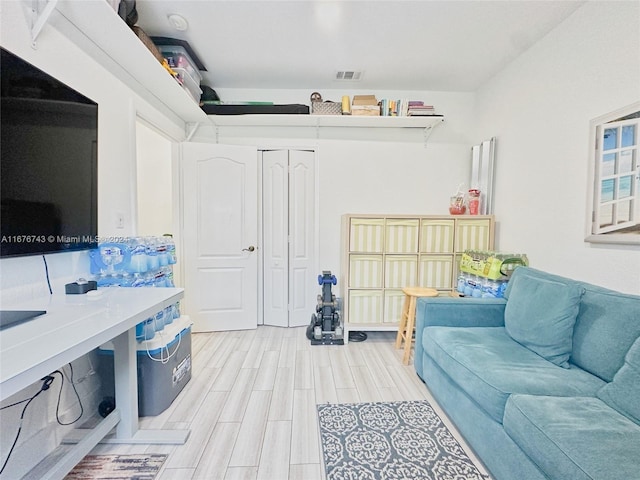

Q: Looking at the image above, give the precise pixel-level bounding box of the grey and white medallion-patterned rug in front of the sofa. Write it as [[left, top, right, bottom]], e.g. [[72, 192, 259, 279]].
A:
[[318, 401, 490, 480]]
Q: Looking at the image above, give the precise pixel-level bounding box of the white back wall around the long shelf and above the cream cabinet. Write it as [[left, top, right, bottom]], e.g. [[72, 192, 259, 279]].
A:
[[193, 90, 475, 294]]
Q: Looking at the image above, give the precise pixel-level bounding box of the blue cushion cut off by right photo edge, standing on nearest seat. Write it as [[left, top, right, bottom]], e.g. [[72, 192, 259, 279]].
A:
[[598, 338, 640, 423]]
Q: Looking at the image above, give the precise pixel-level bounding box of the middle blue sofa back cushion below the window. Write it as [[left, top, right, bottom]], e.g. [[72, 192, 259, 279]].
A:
[[570, 284, 640, 382]]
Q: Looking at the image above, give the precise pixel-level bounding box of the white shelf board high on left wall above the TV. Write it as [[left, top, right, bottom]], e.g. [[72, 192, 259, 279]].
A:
[[51, 0, 208, 123]]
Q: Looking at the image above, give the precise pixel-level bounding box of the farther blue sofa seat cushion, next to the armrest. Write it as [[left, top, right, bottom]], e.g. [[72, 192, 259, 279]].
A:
[[420, 327, 605, 423]]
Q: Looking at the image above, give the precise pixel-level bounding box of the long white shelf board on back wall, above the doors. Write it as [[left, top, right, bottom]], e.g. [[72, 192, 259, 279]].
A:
[[208, 114, 444, 129]]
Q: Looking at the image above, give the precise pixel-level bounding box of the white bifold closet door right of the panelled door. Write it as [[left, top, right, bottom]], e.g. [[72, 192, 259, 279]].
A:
[[262, 150, 319, 327]]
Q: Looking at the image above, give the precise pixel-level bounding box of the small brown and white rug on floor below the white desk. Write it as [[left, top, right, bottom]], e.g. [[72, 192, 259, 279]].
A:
[[64, 454, 167, 480]]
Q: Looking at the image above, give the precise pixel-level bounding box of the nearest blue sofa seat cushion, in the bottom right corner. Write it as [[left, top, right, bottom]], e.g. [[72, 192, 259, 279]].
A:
[[504, 395, 640, 480]]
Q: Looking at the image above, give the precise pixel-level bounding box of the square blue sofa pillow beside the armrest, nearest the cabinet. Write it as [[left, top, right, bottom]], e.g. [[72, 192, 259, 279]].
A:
[[504, 268, 584, 368]]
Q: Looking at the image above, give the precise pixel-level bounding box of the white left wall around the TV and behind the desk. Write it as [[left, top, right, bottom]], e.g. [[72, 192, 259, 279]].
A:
[[0, 0, 184, 478]]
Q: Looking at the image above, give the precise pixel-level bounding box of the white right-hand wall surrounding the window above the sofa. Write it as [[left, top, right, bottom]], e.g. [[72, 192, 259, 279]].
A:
[[474, 1, 640, 294]]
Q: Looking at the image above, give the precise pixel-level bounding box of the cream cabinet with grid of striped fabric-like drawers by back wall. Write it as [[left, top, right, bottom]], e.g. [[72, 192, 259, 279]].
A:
[[339, 214, 495, 338]]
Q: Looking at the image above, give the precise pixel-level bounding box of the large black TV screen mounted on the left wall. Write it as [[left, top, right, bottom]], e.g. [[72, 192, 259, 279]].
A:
[[0, 49, 98, 257]]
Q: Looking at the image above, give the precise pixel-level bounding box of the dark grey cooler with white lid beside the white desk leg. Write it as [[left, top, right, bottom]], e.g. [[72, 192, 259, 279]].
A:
[[98, 316, 193, 417]]
